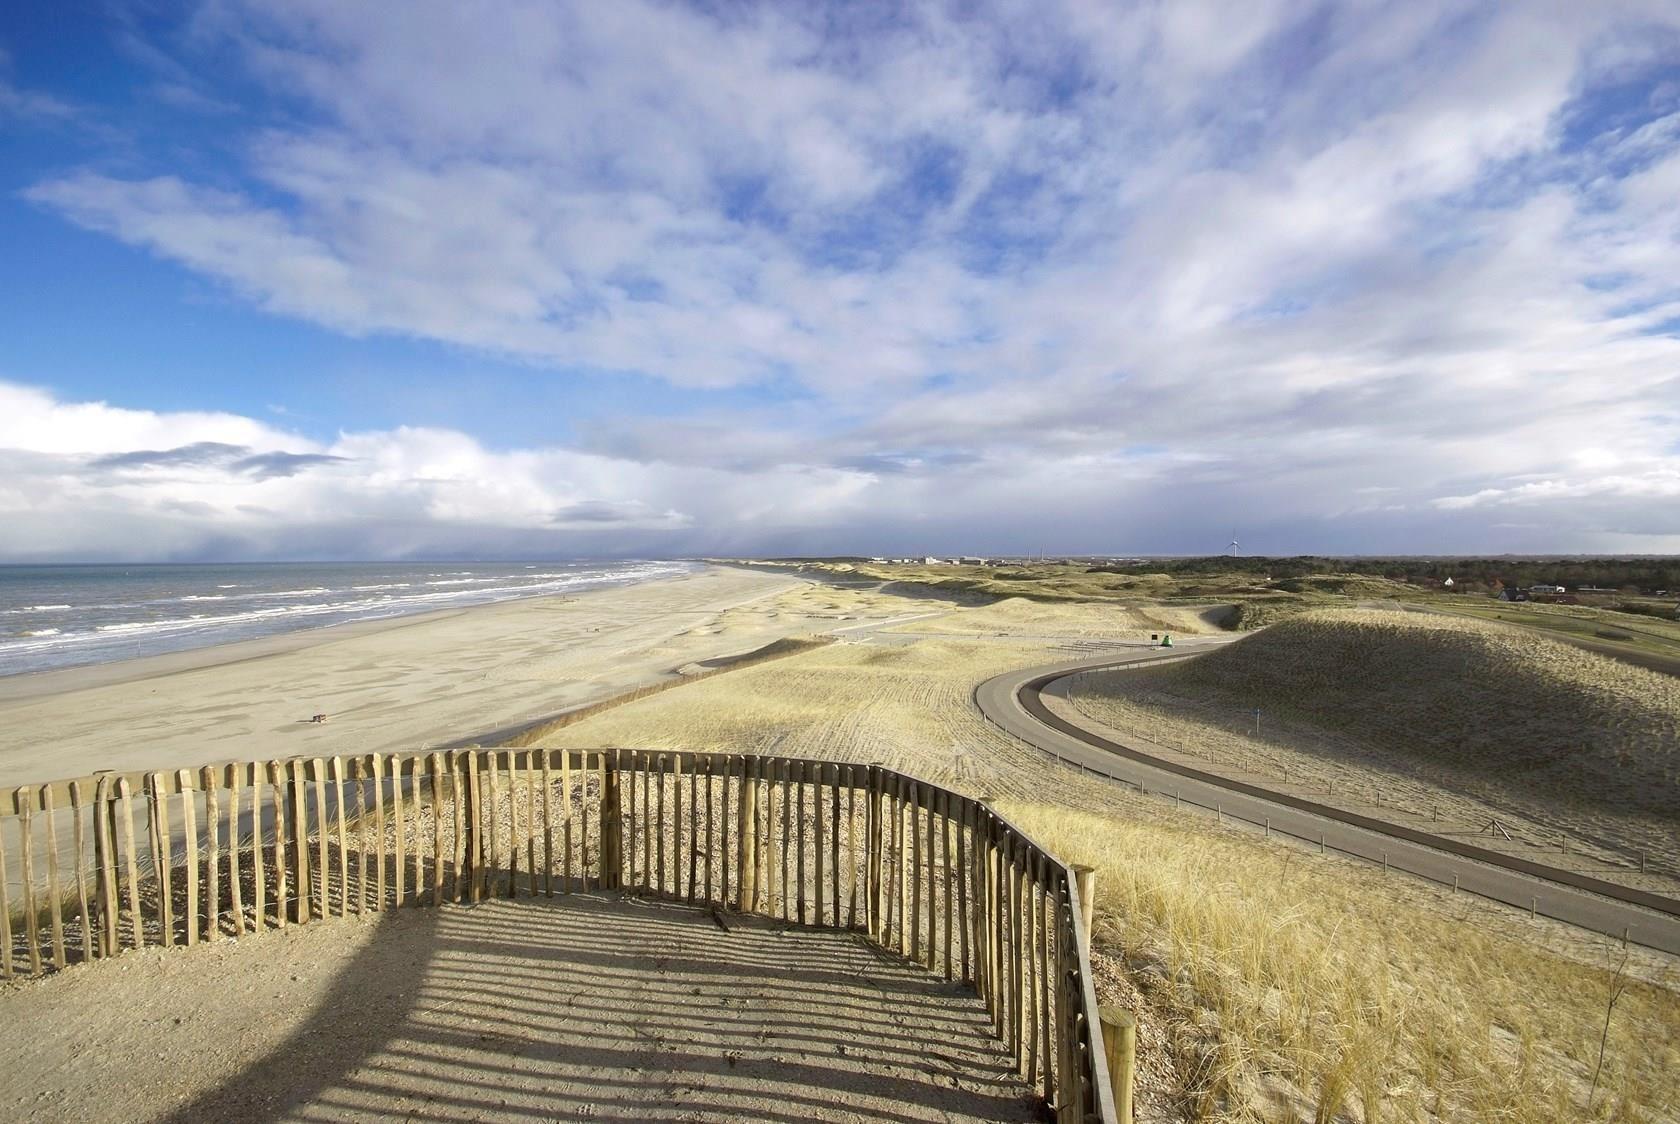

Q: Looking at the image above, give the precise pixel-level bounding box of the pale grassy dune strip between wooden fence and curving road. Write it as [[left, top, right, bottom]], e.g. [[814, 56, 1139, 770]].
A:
[[527, 590, 1680, 1124]]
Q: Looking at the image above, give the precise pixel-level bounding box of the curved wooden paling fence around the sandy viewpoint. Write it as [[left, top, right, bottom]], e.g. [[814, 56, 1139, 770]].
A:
[[0, 749, 1114, 1121]]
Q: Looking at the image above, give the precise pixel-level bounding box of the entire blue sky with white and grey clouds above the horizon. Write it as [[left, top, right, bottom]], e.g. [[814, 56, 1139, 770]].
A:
[[0, 0, 1680, 561]]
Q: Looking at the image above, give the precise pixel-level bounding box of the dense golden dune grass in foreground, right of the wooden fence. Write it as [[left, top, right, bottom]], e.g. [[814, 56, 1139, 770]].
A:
[[1000, 800, 1680, 1124]]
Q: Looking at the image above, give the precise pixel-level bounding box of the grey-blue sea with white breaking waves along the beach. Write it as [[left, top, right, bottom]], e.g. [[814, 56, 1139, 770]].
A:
[[0, 561, 697, 675]]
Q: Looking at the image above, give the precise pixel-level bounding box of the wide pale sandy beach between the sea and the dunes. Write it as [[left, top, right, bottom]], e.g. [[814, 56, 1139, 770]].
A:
[[0, 568, 837, 786]]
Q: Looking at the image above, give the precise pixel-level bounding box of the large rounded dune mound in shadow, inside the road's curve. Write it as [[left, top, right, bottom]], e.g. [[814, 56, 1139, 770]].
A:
[[1068, 608, 1680, 873]]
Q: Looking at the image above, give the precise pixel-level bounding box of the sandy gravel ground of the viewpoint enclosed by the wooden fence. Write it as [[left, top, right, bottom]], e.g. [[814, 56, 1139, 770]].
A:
[[0, 894, 1037, 1121]]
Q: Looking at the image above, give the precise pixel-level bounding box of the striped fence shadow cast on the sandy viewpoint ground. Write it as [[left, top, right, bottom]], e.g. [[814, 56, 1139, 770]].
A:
[[157, 894, 1035, 1122]]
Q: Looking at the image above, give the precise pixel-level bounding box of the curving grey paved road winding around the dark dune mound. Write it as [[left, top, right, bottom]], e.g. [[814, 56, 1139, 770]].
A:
[[974, 645, 1680, 954]]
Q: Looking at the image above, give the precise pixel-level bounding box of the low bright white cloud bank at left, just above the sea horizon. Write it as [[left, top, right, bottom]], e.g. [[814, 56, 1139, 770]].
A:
[[0, 383, 869, 559]]
